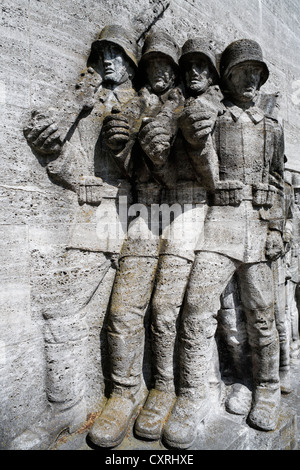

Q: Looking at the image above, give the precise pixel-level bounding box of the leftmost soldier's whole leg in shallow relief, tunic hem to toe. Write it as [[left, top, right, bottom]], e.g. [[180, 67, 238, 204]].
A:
[[7, 250, 110, 450]]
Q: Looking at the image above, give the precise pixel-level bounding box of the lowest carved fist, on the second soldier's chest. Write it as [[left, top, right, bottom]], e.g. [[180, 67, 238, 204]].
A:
[[139, 118, 174, 167]]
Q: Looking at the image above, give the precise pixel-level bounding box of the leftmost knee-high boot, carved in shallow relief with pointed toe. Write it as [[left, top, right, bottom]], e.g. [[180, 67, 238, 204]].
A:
[[11, 315, 88, 450]]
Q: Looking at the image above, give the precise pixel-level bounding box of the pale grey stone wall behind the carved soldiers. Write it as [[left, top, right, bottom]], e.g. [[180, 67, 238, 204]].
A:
[[0, 0, 300, 447]]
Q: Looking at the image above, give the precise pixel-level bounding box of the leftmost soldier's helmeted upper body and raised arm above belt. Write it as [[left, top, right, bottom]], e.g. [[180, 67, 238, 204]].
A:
[[25, 25, 138, 196]]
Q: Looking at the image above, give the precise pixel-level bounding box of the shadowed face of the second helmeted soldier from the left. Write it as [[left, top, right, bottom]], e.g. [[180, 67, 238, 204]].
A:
[[146, 56, 175, 93]]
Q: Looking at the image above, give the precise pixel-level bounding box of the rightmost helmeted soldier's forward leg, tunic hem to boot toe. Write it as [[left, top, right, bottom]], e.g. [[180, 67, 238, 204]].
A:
[[163, 252, 238, 448]]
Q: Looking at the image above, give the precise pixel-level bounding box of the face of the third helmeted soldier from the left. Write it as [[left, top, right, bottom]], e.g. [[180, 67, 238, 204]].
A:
[[185, 57, 212, 95]]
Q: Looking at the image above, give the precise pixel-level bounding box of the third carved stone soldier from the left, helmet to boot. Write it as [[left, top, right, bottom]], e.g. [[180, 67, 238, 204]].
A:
[[135, 39, 222, 440]]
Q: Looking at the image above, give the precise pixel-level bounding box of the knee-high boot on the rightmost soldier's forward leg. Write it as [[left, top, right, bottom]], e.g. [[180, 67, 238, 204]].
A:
[[163, 313, 216, 449]]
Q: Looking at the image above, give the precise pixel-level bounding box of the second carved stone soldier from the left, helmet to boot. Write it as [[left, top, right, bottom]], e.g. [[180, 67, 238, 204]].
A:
[[89, 31, 182, 447]]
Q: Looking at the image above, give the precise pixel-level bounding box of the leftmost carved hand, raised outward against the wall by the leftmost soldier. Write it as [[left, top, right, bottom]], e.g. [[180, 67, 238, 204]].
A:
[[24, 110, 63, 155]]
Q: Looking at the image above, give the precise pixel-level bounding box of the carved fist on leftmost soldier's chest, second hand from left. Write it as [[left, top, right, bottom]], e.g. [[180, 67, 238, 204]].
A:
[[103, 111, 130, 152]]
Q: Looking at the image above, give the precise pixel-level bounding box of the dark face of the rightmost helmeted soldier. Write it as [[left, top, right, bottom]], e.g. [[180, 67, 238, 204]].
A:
[[227, 63, 261, 102]]
